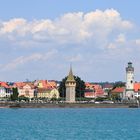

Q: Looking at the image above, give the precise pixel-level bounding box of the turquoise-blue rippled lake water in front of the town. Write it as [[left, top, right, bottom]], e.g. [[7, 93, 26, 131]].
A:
[[0, 108, 140, 140]]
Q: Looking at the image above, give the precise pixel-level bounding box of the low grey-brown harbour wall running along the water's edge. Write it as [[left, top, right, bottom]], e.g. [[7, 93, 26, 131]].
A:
[[0, 103, 138, 108]]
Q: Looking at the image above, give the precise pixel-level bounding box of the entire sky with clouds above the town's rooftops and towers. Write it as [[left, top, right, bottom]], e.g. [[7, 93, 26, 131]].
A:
[[0, 0, 140, 82]]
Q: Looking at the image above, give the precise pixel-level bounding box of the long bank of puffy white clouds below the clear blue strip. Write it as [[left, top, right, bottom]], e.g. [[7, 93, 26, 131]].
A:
[[0, 9, 133, 47]]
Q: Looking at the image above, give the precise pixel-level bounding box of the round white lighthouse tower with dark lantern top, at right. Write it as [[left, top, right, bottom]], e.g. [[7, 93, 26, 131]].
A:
[[125, 62, 134, 100]]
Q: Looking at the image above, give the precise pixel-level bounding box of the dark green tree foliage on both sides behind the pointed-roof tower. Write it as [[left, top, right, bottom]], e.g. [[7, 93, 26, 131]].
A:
[[59, 76, 85, 98]]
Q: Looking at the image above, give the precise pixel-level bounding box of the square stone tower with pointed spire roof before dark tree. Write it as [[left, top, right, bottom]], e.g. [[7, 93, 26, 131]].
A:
[[65, 67, 76, 103]]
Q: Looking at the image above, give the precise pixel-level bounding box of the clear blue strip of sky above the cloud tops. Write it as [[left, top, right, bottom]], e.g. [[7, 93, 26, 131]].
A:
[[0, 0, 140, 23]]
